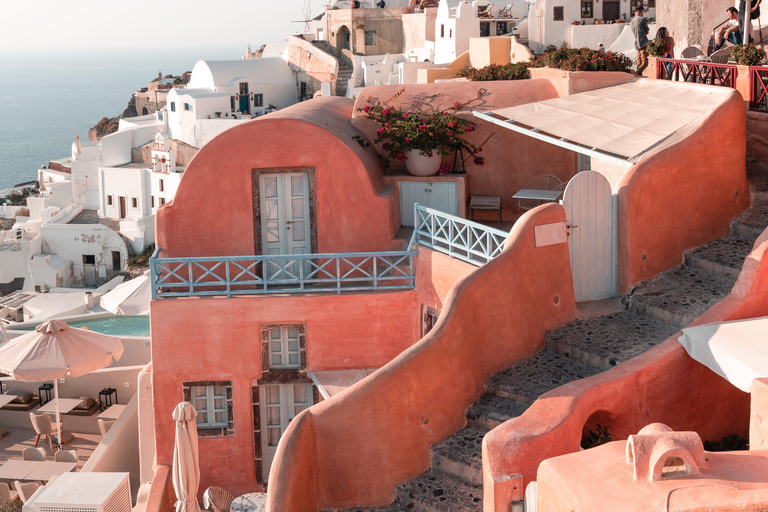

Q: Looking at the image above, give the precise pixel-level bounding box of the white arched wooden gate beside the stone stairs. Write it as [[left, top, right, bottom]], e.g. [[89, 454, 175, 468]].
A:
[[563, 171, 617, 302]]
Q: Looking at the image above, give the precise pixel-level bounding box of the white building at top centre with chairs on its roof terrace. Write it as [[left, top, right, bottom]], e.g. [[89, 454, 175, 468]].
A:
[[435, 0, 528, 64]]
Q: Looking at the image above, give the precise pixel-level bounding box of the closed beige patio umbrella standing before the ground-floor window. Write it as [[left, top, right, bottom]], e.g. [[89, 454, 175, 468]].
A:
[[173, 402, 200, 512]]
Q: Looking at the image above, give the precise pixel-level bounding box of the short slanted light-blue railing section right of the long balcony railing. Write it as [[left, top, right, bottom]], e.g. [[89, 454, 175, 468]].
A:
[[408, 203, 509, 266]]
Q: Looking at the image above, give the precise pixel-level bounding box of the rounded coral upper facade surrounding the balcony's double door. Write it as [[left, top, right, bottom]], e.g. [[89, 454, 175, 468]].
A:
[[156, 98, 402, 257]]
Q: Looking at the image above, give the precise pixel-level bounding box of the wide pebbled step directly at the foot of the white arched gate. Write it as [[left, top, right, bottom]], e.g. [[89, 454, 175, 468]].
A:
[[545, 310, 677, 370]]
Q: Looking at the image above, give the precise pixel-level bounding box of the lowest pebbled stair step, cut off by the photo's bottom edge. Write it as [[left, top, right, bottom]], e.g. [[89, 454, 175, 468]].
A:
[[395, 470, 483, 512]]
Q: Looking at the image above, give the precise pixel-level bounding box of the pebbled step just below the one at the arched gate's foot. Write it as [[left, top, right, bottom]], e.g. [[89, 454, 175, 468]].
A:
[[485, 350, 599, 405]]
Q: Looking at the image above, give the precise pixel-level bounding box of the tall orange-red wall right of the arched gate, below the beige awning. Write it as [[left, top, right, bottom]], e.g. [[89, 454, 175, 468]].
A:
[[617, 92, 749, 294]]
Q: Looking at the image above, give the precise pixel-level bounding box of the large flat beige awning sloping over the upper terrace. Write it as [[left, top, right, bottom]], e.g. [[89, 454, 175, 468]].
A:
[[473, 80, 738, 167]]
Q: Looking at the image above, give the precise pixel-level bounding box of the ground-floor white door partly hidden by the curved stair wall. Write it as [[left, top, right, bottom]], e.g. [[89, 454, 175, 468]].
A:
[[259, 384, 312, 483]]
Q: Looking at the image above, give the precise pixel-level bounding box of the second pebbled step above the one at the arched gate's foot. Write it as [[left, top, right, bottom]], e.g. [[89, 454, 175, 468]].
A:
[[685, 235, 754, 281]]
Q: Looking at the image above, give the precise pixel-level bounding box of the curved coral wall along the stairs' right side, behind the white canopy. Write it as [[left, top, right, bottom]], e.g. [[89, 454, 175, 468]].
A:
[[483, 231, 768, 512]]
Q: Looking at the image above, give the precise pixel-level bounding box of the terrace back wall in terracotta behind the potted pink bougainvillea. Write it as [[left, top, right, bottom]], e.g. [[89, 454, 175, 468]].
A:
[[352, 79, 577, 219]]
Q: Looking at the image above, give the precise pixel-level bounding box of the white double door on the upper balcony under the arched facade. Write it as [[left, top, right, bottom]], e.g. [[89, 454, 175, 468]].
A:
[[259, 172, 312, 276]]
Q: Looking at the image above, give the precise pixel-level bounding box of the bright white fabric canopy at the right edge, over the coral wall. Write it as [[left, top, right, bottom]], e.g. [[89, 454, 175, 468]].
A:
[[678, 317, 768, 393]]
